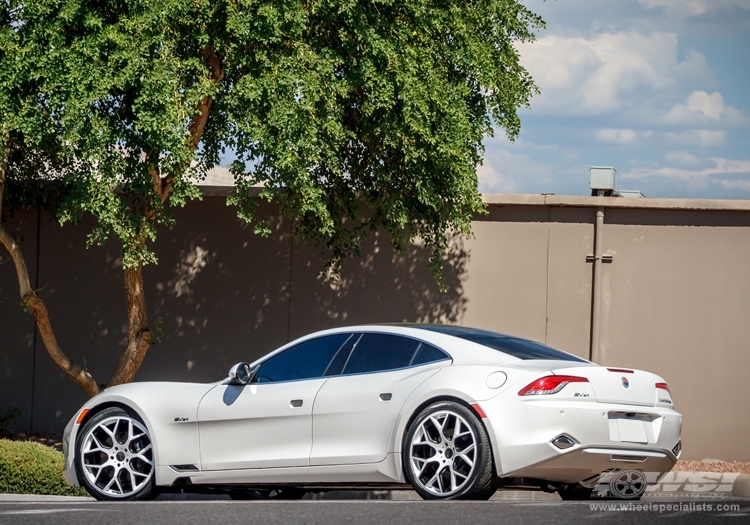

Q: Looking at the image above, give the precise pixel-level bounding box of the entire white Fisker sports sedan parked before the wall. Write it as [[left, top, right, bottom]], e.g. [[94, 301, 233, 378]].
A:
[[64, 325, 682, 500]]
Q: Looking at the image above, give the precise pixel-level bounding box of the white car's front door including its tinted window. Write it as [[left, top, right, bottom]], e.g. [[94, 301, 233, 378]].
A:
[[198, 333, 351, 470]]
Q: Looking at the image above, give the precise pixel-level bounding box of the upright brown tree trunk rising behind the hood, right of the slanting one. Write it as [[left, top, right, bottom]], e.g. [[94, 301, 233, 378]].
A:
[[107, 265, 151, 387]]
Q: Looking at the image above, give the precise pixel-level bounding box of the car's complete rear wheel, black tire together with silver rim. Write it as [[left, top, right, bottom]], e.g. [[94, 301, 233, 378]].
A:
[[403, 401, 499, 500]]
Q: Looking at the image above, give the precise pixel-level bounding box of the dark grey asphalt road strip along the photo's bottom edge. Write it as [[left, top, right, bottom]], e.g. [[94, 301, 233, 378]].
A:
[[0, 499, 750, 525]]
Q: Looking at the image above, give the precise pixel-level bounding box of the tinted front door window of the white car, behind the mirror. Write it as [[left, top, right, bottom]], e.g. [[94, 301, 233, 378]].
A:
[[254, 334, 351, 383]]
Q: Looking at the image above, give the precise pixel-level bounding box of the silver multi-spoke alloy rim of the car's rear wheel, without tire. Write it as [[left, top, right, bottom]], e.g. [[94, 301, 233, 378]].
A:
[[409, 410, 477, 496]]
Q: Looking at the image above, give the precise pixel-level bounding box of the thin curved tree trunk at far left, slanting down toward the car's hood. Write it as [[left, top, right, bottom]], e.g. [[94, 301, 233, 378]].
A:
[[0, 128, 99, 396]]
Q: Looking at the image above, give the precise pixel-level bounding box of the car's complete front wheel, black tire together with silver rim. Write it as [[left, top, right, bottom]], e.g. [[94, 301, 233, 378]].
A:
[[75, 407, 157, 501]]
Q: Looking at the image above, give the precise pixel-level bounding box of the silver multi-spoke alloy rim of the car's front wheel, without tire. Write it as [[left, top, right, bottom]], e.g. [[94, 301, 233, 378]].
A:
[[80, 415, 154, 498]]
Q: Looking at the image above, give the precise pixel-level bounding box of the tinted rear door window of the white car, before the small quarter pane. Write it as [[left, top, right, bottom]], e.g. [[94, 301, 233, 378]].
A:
[[344, 334, 420, 374]]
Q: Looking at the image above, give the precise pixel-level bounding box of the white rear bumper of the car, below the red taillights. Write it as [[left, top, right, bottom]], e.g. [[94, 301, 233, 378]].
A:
[[481, 397, 682, 483]]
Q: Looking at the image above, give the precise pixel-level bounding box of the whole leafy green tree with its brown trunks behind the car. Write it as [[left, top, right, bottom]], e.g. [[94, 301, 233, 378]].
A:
[[0, 0, 543, 395]]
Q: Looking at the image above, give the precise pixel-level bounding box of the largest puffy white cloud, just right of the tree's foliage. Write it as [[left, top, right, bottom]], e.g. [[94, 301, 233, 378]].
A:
[[519, 31, 712, 115]]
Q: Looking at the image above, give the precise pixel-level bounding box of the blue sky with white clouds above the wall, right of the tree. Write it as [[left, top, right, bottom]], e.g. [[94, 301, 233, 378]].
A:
[[477, 0, 750, 199]]
